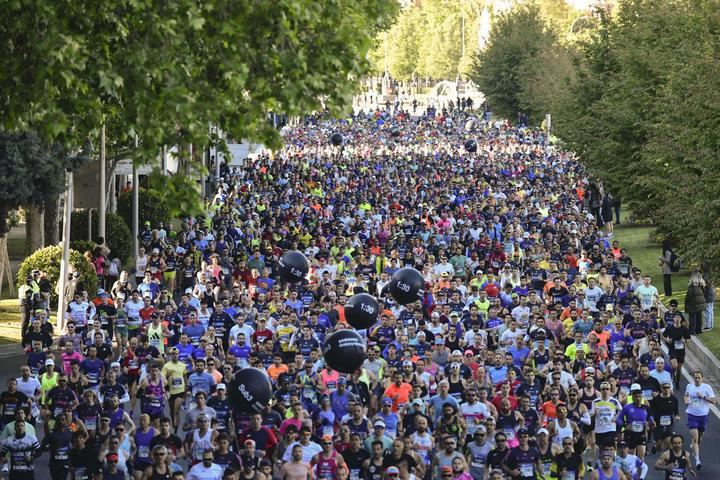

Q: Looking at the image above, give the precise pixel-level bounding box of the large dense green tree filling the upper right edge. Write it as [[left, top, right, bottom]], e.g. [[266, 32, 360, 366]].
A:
[[555, 0, 720, 275]]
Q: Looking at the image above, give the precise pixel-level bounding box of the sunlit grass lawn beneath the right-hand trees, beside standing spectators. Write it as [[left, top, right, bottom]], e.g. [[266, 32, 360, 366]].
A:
[[615, 220, 720, 357]]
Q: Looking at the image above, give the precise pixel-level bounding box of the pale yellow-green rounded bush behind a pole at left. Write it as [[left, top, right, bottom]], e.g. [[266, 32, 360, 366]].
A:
[[17, 245, 98, 304]]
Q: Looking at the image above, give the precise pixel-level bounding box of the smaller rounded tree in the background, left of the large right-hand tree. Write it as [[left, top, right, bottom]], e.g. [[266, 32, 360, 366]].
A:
[[471, 3, 558, 120]]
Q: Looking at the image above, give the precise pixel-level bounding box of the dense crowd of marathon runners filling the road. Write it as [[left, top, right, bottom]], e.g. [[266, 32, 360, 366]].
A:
[[0, 111, 715, 480]]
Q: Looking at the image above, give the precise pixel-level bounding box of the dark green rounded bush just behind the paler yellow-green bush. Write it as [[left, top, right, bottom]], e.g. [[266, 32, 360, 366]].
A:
[[70, 210, 133, 263]]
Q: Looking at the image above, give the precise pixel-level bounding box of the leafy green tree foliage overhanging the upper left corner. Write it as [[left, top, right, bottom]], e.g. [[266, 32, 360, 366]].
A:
[[0, 0, 398, 212]]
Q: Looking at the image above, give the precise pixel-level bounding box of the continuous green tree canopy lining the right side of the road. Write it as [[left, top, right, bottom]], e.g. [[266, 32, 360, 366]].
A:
[[475, 0, 720, 271]]
